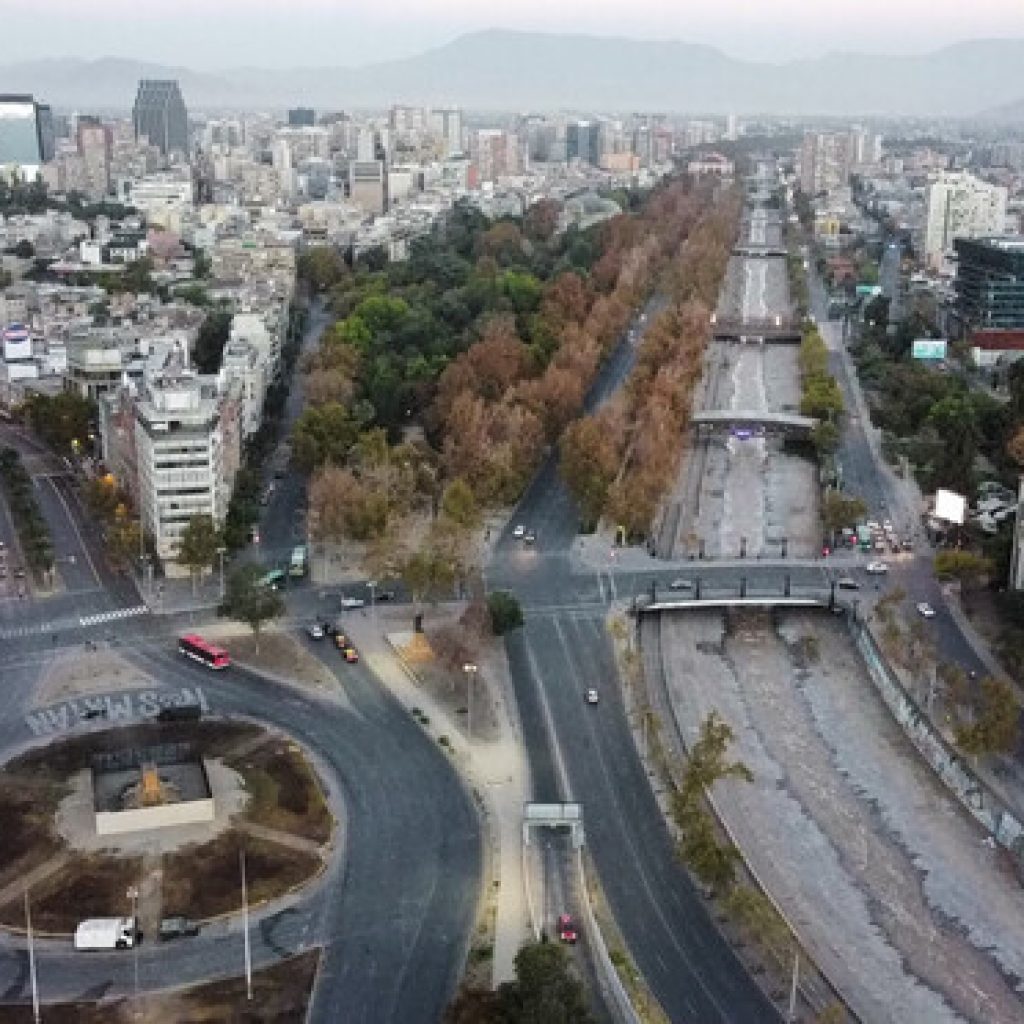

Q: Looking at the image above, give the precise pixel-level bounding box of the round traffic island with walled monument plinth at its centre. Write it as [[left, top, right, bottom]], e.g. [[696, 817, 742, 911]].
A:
[[0, 722, 335, 934]]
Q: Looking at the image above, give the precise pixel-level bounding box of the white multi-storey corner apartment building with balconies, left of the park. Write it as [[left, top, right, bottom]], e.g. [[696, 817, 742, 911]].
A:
[[134, 359, 239, 562]]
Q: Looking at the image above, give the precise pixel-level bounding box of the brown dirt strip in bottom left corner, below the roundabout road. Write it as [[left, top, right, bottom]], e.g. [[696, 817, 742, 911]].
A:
[[0, 949, 319, 1024]]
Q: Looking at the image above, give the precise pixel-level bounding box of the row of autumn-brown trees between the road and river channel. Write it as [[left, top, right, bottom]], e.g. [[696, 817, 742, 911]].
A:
[[561, 190, 741, 538]]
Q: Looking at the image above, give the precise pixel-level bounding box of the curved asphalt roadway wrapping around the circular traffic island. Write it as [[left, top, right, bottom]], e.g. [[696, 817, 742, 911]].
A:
[[0, 627, 481, 1024]]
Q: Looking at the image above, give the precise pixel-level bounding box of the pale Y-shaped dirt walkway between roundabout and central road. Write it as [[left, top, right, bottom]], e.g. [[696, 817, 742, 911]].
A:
[[337, 608, 532, 985]]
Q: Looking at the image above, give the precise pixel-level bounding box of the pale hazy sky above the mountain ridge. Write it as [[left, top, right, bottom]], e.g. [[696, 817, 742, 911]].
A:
[[8, 0, 1024, 70]]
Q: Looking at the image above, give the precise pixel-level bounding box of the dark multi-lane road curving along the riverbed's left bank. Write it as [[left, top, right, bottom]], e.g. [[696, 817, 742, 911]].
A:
[[486, 292, 777, 1024]]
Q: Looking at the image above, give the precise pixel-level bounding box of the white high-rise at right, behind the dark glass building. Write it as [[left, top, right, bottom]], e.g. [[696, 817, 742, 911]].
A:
[[924, 171, 1007, 267]]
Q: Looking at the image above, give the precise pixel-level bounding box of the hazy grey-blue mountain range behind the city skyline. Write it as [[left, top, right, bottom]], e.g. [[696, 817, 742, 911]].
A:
[[0, 30, 1024, 117]]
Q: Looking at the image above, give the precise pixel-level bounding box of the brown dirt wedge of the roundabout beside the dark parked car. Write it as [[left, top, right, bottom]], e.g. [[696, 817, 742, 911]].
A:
[[164, 829, 322, 920]]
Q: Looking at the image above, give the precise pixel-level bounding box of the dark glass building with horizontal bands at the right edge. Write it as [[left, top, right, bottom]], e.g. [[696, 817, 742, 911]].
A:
[[953, 236, 1024, 331]]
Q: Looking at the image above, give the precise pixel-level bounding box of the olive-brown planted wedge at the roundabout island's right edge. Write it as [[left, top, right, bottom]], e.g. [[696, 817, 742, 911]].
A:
[[227, 737, 334, 843]]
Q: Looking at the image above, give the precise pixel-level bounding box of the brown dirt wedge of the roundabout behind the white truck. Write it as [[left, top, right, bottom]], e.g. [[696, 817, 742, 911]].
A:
[[0, 853, 142, 935]]
